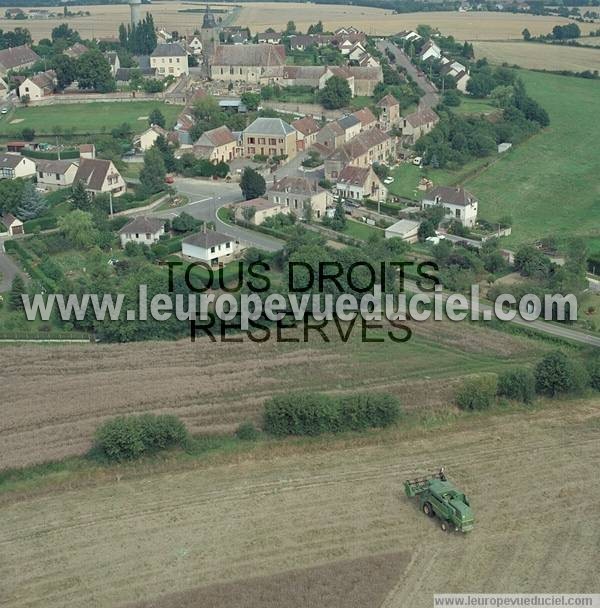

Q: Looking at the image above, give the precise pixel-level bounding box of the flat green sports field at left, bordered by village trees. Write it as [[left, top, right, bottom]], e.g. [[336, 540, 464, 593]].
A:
[[0, 101, 181, 137]]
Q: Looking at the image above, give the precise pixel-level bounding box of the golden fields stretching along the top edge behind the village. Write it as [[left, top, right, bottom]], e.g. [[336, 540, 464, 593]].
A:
[[0, 1, 597, 40]]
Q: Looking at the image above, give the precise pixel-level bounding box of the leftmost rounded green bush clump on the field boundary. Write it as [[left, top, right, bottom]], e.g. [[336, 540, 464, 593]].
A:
[[95, 414, 188, 461]]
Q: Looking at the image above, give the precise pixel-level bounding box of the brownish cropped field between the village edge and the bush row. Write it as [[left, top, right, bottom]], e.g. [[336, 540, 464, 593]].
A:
[[0, 322, 540, 470]]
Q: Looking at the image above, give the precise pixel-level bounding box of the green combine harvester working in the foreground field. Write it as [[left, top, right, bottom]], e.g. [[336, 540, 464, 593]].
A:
[[404, 467, 475, 532]]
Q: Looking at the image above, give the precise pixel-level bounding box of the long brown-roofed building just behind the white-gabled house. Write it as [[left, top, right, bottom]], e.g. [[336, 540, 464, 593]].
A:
[[325, 127, 396, 181]]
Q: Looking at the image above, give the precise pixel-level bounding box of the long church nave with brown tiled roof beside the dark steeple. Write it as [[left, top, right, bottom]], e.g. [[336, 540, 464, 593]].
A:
[[210, 44, 285, 85]]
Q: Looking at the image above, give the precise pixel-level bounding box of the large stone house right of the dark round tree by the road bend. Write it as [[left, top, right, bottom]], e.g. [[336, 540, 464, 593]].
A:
[[266, 177, 333, 219]]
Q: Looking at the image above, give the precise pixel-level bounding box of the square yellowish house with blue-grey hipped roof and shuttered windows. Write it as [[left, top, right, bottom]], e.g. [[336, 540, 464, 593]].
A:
[[242, 118, 297, 159]]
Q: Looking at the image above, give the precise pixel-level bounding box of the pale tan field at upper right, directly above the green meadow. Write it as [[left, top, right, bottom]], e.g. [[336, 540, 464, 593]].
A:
[[473, 42, 600, 72]]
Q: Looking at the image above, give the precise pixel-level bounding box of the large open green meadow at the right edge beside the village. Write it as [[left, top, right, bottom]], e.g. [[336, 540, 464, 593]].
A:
[[464, 70, 600, 245]]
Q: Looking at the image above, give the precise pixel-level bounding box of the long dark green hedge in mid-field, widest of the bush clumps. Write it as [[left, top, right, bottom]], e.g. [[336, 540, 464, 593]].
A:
[[263, 393, 400, 437]]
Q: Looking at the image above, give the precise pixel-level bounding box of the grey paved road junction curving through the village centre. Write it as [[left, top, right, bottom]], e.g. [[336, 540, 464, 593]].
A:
[[151, 177, 283, 251]]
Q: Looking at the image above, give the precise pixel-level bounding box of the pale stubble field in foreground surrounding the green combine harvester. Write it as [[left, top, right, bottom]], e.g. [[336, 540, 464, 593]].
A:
[[0, 400, 600, 608]]
